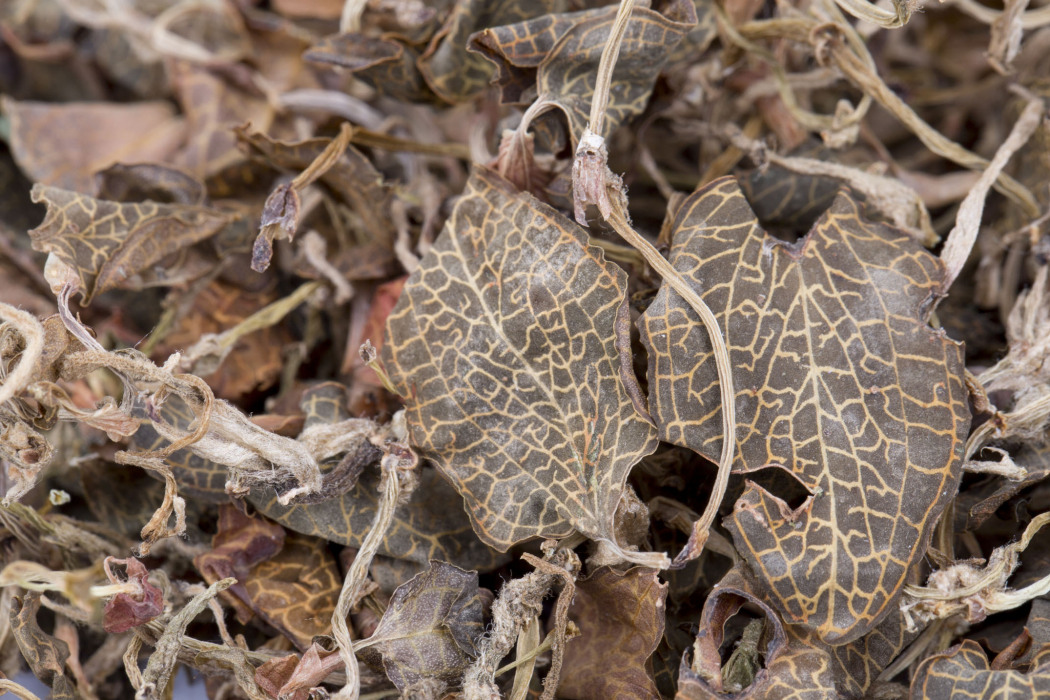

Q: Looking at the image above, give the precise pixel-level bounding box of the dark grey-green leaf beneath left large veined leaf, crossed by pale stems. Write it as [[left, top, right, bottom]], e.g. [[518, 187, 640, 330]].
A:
[[132, 396, 507, 571]]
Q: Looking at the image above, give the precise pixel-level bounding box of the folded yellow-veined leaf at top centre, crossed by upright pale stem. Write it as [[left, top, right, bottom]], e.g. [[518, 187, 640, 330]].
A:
[[470, 0, 696, 149]]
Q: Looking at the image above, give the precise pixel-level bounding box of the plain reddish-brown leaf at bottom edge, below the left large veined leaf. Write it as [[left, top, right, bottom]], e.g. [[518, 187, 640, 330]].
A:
[[558, 567, 667, 700]]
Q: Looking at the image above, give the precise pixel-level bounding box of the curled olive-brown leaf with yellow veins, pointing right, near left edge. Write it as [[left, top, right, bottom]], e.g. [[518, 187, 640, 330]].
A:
[[29, 185, 230, 305]]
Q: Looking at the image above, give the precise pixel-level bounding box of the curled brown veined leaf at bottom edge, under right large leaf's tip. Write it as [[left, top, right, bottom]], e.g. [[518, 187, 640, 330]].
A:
[[676, 568, 916, 700]]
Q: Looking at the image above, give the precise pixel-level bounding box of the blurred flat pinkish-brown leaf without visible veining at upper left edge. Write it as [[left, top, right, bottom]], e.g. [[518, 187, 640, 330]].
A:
[[0, 98, 186, 194]]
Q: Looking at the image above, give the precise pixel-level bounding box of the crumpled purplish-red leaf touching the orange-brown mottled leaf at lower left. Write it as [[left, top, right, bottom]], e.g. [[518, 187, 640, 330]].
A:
[[193, 505, 285, 622]]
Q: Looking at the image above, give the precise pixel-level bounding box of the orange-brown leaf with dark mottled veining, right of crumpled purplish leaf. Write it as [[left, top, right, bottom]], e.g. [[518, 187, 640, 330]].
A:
[[244, 532, 342, 650]]
